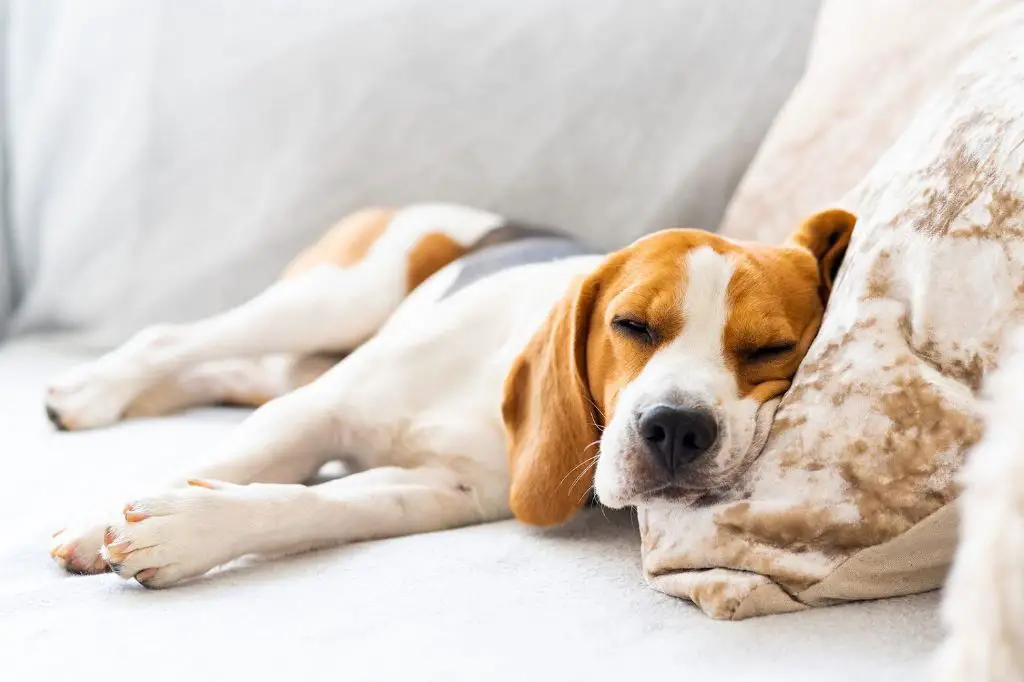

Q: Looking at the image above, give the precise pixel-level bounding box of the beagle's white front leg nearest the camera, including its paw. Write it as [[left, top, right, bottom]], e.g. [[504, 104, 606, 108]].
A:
[[104, 467, 508, 588]]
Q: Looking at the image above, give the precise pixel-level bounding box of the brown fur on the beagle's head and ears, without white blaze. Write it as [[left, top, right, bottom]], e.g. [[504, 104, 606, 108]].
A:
[[502, 211, 855, 525]]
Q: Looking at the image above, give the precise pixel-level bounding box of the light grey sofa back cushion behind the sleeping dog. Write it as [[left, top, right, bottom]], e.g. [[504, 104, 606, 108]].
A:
[[8, 0, 819, 344]]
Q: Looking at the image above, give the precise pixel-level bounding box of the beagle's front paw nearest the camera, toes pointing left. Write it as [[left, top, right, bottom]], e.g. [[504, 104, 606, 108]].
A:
[[101, 481, 251, 588]]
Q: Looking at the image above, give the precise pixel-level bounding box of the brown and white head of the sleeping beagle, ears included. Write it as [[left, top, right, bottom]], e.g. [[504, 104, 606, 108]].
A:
[[502, 210, 856, 525]]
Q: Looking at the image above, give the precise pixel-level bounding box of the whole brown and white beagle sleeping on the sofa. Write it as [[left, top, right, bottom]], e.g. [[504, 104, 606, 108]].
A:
[[46, 205, 855, 587]]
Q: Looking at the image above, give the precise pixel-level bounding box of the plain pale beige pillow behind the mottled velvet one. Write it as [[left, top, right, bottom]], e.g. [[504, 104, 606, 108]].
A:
[[721, 0, 1024, 244]]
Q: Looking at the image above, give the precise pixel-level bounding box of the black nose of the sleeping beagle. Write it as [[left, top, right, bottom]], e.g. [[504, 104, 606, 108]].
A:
[[640, 404, 718, 473]]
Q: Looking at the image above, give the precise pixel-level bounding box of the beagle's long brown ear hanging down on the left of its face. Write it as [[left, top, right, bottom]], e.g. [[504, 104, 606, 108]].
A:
[[502, 278, 600, 525]]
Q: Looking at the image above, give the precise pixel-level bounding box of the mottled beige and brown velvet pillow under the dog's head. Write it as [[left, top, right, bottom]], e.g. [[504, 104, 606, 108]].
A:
[[640, 30, 1024, 619]]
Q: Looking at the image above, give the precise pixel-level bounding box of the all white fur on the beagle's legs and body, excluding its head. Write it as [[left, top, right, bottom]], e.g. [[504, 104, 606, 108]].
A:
[[49, 200, 600, 587]]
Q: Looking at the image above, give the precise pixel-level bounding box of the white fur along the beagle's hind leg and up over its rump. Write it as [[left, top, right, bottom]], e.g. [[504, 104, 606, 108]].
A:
[[47, 204, 502, 429]]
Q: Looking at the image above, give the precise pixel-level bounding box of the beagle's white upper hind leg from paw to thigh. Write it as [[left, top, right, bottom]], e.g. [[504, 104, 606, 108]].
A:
[[47, 259, 404, 429]]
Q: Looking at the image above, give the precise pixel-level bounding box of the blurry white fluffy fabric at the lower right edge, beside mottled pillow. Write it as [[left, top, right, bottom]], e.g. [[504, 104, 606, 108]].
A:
[[935, 323, 1024, 682]]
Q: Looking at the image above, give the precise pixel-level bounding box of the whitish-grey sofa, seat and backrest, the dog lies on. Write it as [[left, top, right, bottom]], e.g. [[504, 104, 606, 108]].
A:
[[0, 0, 940, 682]]
